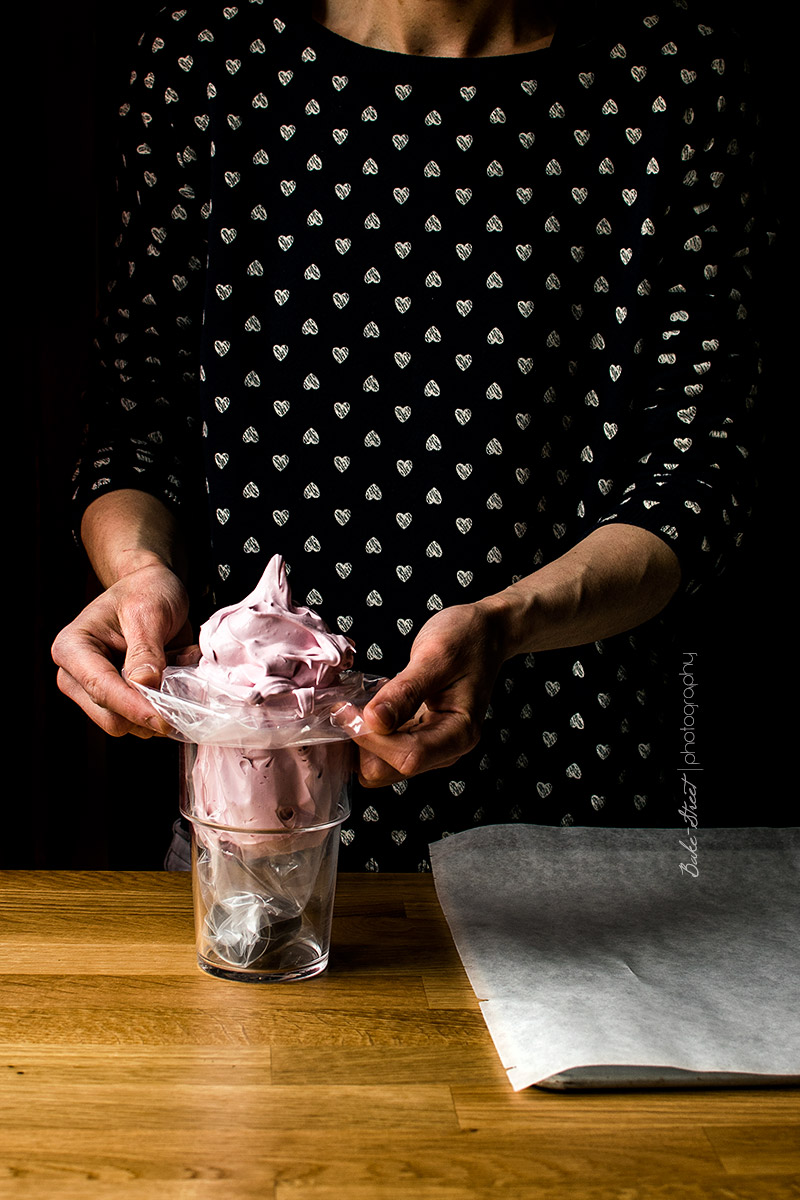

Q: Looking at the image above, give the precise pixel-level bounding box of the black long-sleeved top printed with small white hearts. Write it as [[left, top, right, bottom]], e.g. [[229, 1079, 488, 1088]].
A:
[[82, 7, 751, 869]]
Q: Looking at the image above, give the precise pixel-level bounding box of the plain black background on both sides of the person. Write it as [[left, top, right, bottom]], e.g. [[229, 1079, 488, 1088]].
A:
[[18, 0, 798, 869]]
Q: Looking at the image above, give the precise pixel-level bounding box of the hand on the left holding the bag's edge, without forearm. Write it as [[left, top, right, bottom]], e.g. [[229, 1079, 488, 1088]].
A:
[[53, 563, 193, 738]]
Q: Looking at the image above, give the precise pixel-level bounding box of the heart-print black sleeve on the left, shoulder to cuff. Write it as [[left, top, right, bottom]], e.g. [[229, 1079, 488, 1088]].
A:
[[76, 14, 210, 512]]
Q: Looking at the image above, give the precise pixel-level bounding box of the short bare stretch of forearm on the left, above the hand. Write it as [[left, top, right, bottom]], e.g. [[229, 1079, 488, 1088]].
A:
[[80, 488, 186, 588]]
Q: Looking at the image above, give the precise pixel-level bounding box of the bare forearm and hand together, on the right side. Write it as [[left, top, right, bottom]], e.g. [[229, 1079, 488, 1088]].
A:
[[359, 524, 680, 787]]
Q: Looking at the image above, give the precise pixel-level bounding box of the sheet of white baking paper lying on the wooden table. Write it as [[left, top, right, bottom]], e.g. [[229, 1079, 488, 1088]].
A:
[[431, 824, 800, 1091]]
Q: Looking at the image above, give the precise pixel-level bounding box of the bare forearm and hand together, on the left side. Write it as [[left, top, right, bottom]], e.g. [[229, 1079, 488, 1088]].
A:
[[53, 490, 192, 737]]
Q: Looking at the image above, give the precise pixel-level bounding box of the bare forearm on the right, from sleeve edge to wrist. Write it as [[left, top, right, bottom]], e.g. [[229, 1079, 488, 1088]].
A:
[[481, 524, 680, 659]]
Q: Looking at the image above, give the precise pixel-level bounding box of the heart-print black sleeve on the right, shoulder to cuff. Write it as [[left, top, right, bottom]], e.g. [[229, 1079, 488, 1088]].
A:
[[597, 30, 770, 590]]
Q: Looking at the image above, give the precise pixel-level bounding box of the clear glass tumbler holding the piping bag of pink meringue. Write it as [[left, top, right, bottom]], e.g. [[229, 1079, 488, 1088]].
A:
[[181, 743, 351, 983]]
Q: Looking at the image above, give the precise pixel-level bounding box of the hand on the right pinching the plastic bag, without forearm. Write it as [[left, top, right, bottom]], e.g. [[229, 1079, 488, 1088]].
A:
[[355, 601, 505, 787]]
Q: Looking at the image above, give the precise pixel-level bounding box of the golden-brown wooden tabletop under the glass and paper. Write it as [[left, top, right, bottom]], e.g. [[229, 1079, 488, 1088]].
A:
[[0, 871, 800, 1200]]
